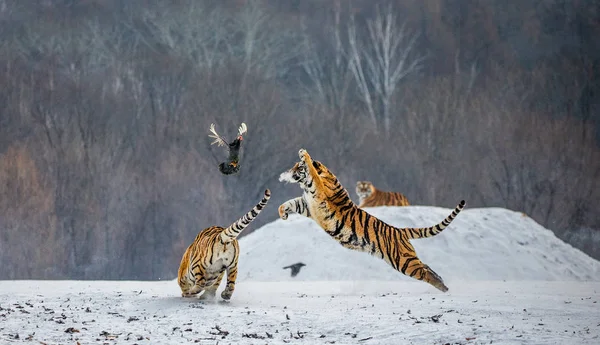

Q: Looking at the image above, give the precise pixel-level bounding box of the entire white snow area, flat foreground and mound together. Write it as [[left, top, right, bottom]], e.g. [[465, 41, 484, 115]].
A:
[[0, 206, 600, 345]]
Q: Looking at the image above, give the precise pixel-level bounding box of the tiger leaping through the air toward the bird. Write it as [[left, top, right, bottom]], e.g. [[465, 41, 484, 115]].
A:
[[279, 149, 465, 291]]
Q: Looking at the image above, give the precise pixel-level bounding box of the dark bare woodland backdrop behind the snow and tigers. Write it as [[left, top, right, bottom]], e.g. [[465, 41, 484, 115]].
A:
[[0, 0, 600, 279]]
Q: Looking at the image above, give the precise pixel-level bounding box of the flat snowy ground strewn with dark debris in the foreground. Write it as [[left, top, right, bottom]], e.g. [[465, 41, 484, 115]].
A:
[[0, 281, 600, 345]]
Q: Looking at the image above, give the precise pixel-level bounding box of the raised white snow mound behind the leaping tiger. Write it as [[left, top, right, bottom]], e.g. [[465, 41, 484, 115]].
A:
[[238, 206, 600, 283]]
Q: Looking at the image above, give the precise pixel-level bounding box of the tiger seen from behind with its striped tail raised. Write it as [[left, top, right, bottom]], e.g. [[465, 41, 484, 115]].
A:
[[177, 189, 271, 300]]
